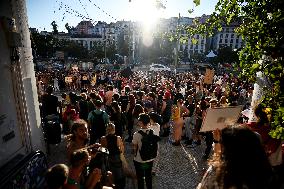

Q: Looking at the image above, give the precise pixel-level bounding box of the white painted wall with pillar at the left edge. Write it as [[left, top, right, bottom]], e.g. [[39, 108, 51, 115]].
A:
[[0, 0, 45, 166]]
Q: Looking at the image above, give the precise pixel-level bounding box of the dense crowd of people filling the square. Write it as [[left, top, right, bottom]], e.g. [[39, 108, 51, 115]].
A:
[[37, 70, 282, 189]]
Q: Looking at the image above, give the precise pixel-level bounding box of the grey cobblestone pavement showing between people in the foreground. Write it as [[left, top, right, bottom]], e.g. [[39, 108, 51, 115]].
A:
[[48, 134, 207, 189]]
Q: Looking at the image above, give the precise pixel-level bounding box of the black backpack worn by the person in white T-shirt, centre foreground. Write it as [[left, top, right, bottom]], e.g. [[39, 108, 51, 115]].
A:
[[138, 129, 160, 161]]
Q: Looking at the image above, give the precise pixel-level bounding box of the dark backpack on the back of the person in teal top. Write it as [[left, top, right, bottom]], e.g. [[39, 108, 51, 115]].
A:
[[91, 111, 106, 137]]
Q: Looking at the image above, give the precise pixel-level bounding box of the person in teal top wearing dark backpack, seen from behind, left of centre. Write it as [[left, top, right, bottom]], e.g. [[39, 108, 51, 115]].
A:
[[88, 100, 109, 144]]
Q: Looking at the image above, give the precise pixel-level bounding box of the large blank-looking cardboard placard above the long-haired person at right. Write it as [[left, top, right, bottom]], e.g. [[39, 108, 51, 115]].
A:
[[200, 106, 243, 132]]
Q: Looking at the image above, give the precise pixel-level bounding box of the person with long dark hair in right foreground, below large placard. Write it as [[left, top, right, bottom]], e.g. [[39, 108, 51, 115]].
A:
[[197, 125, 277, 189]]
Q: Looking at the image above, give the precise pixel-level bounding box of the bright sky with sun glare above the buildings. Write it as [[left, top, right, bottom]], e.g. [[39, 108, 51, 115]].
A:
[[26, 0, 217, 31]]
